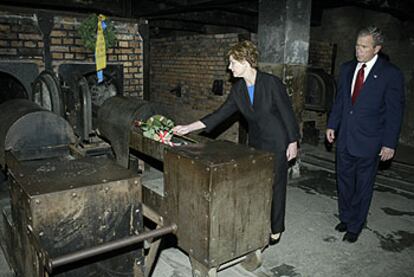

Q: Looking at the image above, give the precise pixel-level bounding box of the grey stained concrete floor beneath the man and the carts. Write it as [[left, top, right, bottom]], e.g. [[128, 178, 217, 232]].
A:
[[0, 144, 414, 277]]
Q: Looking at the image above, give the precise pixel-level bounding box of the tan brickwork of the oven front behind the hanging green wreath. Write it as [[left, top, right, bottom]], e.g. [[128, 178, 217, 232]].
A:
[[0, 11, 143, 97]]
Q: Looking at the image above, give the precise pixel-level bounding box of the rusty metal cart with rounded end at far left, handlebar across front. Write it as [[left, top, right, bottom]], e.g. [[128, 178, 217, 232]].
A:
[[0, 99, 176, 277]]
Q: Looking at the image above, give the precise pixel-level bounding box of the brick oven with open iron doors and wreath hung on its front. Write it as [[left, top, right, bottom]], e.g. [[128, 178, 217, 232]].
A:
[[0, 8, 143, 140]]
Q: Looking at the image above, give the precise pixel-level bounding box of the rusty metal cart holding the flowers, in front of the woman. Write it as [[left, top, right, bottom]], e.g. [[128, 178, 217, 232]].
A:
[[98, 97, 273, 276]]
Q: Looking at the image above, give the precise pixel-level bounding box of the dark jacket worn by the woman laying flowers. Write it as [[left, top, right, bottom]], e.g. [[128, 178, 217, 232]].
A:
[[201, 71, 299, 152]]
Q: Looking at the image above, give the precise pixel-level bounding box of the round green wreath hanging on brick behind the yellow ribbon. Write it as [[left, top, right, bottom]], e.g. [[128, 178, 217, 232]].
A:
[[78, 14, 117, 52]]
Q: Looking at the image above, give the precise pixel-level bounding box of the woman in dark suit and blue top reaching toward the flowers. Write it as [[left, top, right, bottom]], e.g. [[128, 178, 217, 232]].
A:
[[173, 41, 299, 243]]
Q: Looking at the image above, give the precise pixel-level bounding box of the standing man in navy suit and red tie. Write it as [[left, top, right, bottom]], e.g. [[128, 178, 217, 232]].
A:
[[326, 26, 404, 243]]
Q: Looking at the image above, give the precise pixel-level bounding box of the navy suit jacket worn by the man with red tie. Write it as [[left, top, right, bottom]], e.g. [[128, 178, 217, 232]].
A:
[[328, 57, 405, 157]]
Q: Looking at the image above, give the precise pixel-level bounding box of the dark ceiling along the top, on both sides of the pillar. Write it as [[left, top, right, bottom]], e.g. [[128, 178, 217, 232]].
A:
[[0, 0, 414, 35]]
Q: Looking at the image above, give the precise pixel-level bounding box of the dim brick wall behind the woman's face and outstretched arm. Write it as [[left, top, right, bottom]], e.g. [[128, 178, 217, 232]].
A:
[[150, 34, 238, 141]]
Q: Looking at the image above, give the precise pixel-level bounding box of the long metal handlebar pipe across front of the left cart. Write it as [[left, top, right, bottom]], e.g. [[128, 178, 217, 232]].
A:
[[46, 223, 177, 274]]
